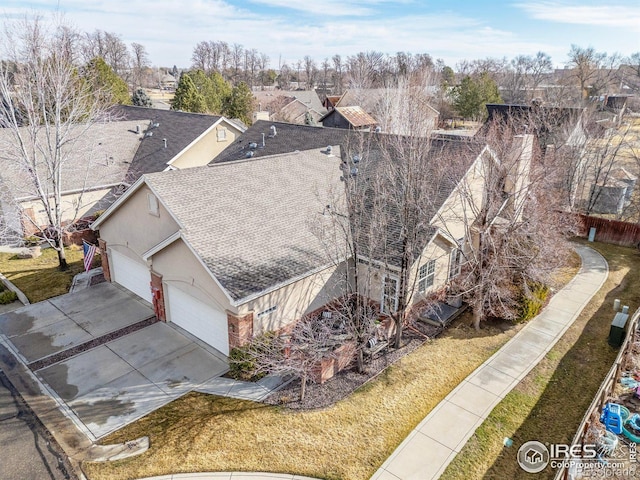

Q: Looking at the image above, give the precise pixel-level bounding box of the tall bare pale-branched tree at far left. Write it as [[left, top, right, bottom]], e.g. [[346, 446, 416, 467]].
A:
[[0, 18, 112, 269]]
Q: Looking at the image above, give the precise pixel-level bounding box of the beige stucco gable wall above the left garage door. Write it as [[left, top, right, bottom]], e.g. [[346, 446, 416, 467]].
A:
[[100, 184, 178, 262]]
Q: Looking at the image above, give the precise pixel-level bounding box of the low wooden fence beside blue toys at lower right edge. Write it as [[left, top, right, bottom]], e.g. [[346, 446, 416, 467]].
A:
[[555, 308, 640, 480]]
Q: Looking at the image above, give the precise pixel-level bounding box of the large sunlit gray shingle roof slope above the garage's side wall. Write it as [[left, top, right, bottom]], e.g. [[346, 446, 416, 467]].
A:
[[145, 150, 344, 300]]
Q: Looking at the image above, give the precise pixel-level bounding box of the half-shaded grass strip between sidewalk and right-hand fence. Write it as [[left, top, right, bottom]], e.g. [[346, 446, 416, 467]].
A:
[[440, 243, 640, 480]]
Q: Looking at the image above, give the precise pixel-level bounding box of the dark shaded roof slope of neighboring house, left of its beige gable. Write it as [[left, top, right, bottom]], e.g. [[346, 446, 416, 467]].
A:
[[113, 105, 222, 176]]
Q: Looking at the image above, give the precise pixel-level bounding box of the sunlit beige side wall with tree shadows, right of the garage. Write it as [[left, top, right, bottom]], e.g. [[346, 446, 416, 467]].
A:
[[240, 263, 346, 333]]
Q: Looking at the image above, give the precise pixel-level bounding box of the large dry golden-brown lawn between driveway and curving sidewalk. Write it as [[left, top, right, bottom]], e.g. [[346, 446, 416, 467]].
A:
[[84, 317, 517, 480]]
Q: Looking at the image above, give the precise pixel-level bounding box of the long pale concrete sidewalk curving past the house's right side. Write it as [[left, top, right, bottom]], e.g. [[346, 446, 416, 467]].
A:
[[372, 246, 608, 480]]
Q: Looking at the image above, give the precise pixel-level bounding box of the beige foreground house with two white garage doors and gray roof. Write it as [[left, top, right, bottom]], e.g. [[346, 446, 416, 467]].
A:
[[92, 122, 528, 355]]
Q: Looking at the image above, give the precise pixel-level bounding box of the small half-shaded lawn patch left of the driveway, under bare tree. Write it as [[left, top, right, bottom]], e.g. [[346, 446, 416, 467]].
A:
[[0, 246, 100, 303]]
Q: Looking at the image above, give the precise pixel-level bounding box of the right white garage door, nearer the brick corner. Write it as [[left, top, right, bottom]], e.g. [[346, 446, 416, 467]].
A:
[[167, 286, 229, 355]]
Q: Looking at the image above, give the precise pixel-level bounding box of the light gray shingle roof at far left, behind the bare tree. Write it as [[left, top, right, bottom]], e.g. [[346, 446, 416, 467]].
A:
[[0, 122, 140, 199]]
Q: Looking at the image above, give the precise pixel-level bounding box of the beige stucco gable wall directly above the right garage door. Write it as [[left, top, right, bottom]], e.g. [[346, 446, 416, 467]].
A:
[[150, 239, 237, 313]]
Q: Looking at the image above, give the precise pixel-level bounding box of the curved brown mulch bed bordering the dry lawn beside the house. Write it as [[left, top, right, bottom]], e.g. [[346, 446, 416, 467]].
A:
[[263, 322, 443, 410]]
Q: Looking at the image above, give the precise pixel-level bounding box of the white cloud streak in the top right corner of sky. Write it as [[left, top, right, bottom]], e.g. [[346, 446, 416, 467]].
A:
[[515, 2, 640, 30]]
